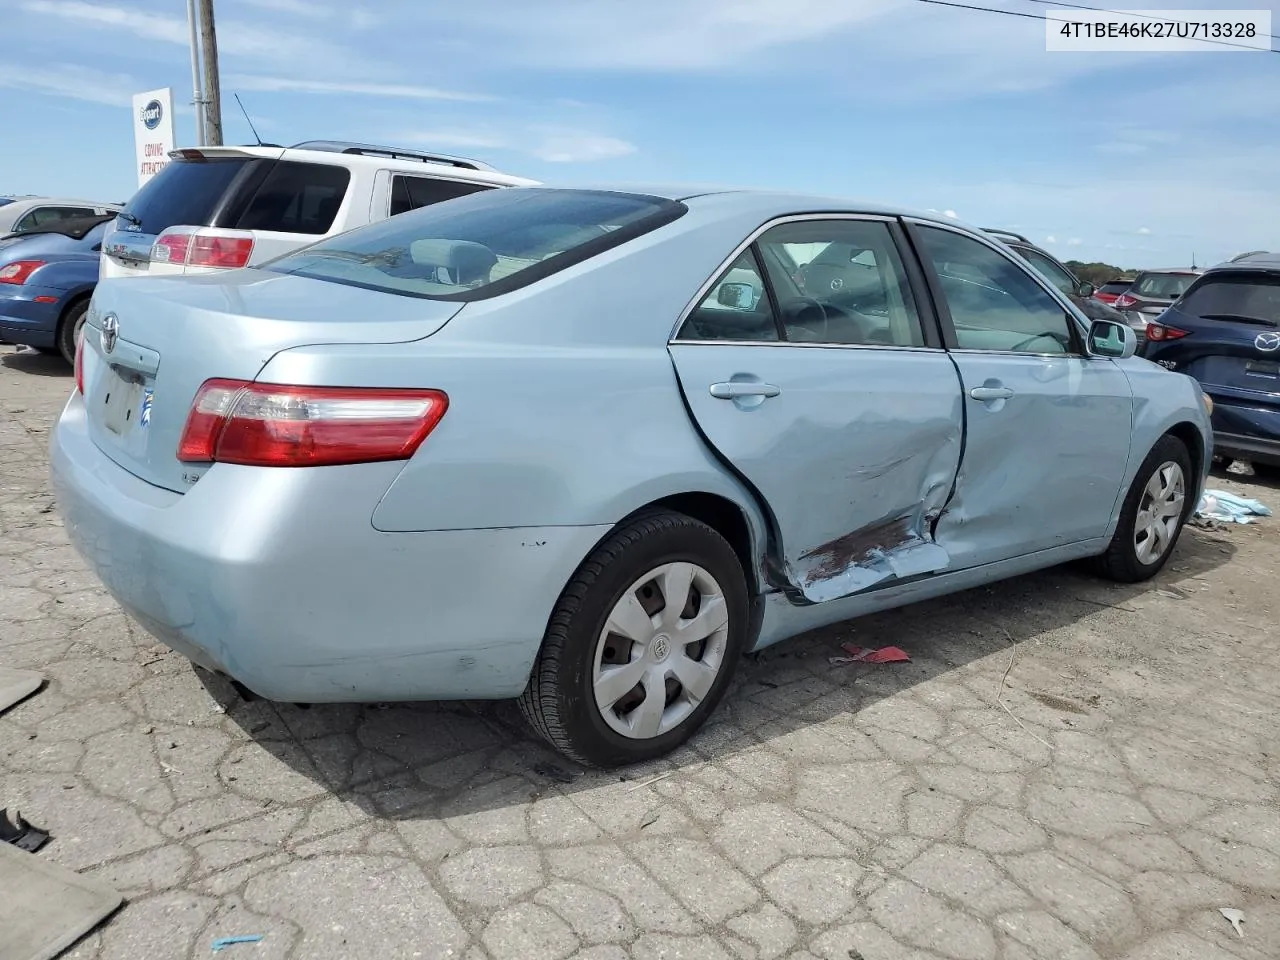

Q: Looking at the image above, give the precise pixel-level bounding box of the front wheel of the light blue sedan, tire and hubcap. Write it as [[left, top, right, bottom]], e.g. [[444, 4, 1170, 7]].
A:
[[1098, 435, 1196, 584]]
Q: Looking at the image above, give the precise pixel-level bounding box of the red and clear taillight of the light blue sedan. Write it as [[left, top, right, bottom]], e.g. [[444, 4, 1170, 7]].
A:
[[178, 380, 449, 467]]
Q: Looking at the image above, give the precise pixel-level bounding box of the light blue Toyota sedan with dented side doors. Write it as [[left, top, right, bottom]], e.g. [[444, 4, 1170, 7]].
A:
[[52, 188, 1212, 765]]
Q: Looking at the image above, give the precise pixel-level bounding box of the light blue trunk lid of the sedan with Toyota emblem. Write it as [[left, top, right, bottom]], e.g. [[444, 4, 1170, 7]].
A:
[[83, 270, 462, 493]]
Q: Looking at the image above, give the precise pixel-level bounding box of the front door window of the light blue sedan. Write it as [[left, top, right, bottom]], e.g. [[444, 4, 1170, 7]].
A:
[[918, 227, 1074, 353]]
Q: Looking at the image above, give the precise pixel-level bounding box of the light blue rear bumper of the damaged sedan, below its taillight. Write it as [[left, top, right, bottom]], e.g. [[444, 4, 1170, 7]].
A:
[[50, 394, 607, 703]]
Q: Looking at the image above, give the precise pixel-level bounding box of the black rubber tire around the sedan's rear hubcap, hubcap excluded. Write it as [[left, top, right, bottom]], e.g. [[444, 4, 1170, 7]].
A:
[[520, 511, 749, 767]]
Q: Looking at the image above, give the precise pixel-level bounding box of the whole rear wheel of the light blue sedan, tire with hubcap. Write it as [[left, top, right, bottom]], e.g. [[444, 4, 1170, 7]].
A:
[[520, 512, 748, 767]]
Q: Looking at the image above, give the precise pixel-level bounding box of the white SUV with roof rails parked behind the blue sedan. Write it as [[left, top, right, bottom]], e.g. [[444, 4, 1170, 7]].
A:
[[99, 140, 536, 279]]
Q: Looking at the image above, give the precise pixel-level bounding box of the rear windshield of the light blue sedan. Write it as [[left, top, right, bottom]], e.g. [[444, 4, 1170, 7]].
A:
[[266, 187, 685, 301]]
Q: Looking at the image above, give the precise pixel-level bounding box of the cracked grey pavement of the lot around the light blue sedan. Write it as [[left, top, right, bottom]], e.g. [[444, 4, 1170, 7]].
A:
[[0, 347, 1280, 960]]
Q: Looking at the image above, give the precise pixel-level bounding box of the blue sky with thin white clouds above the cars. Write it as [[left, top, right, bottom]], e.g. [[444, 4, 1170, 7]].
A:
[[0, 0, 1280, 268]]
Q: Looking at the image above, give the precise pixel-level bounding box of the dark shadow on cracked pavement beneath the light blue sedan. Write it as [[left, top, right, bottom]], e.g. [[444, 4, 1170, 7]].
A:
[[197, 527, 1235, 828]]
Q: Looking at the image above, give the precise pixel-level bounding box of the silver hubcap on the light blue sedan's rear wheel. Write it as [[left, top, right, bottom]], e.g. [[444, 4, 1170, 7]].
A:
[[591, 563, 728, 740]]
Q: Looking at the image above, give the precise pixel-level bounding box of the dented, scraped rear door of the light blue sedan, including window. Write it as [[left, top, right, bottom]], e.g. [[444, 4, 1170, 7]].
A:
[[669, 225, 963, 603]]
